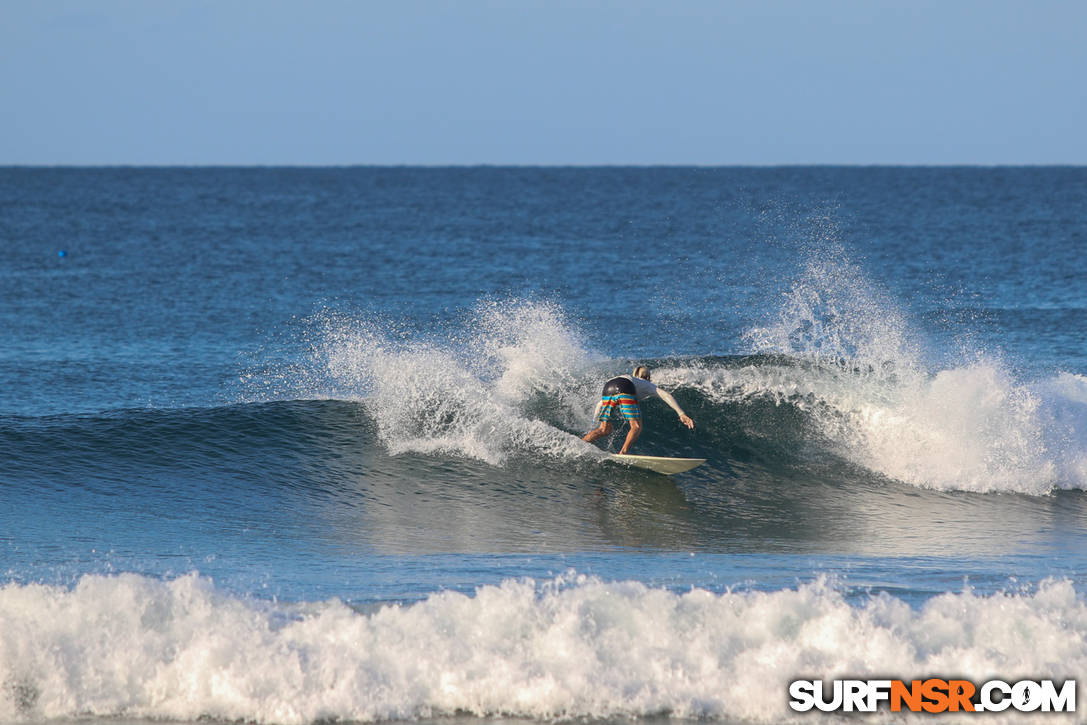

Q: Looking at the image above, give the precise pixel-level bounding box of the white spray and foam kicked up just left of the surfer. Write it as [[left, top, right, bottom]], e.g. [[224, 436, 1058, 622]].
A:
[[309, 301, 595, 465]]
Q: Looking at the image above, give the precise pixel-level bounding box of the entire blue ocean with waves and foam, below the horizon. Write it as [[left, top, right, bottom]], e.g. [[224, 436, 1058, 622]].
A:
[[0, 167, 1087, 724]]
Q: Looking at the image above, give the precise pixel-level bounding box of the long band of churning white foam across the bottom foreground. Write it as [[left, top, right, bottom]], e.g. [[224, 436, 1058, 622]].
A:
[[0, 574, 1087, 725]]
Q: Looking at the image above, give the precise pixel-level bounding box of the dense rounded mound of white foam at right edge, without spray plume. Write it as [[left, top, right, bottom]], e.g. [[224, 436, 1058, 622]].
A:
[[821, 361, 1087, 495]]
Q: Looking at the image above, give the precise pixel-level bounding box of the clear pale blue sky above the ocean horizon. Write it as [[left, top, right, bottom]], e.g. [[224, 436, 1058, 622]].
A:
[[0, 0, 1087, 165]]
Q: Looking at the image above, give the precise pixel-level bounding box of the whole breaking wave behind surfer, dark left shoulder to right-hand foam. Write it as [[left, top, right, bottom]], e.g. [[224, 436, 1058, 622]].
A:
[[8, 356, 1087, 495]]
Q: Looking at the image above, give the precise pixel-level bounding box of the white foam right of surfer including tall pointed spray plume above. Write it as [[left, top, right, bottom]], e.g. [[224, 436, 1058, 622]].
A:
[[734, 235, 1087, 495]]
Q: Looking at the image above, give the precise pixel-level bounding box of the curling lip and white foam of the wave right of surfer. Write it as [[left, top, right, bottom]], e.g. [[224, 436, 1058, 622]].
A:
[[660, 358, 1087, 495]]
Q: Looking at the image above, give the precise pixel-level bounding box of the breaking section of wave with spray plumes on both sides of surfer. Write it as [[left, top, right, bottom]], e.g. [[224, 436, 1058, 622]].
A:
[[227, 291, 1087, 495]]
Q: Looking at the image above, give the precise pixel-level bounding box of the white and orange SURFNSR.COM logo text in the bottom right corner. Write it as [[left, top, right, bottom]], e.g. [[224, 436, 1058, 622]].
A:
[[789, 677, 1076, 713]]
